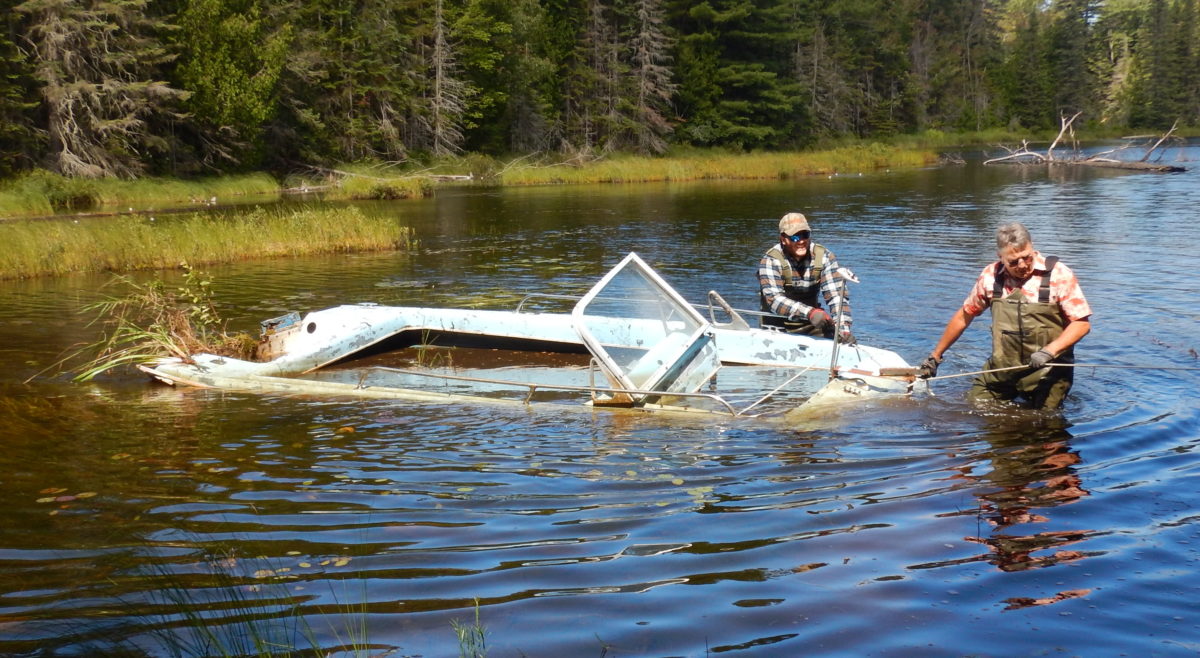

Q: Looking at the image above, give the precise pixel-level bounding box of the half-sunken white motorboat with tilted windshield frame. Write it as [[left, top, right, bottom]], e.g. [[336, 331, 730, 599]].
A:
[[139, 253, 913, 417]]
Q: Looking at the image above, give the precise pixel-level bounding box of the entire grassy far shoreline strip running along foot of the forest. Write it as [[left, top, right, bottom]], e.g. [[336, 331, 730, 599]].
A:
[[0, 143, 938, 225]]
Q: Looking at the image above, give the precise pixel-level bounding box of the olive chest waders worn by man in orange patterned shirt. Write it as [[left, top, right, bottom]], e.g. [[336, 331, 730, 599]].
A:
[[967, 256, 1075, 409]]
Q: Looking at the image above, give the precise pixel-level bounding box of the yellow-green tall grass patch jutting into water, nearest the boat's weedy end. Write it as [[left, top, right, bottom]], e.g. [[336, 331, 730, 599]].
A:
[[0, 207, 413, 279]]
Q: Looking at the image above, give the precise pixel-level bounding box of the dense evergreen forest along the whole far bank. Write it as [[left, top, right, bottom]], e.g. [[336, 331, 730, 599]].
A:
[[0, 0, 1200, 178]]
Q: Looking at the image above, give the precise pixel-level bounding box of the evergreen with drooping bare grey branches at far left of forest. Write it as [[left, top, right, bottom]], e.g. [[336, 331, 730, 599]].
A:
[[16, 0, 186, 178]]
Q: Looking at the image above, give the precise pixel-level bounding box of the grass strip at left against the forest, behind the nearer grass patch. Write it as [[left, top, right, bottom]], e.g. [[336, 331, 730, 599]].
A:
[[0, 171, 280, 219]]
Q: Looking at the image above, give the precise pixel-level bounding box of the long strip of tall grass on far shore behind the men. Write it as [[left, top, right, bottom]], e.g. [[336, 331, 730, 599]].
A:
[[499, 144, 937, 185]]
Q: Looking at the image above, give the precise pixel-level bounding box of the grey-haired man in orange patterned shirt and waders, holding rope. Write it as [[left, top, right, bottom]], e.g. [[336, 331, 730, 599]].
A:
[[919, 222, 1092, 409]]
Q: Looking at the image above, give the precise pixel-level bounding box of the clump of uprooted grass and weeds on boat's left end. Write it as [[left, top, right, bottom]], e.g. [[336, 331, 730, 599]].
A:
[[68, 263, 258, 382]]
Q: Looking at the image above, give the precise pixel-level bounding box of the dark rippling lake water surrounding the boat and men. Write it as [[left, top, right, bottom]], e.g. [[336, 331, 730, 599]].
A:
[[0, 148, 1200, 657]]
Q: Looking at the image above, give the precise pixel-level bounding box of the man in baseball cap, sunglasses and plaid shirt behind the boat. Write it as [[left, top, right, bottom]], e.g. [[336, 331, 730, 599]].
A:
[[758, 213, 854, 345]]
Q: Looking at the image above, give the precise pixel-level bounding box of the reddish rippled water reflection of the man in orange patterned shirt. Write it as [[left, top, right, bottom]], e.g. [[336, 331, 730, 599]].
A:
[[967, 425, 1091, 572]]
